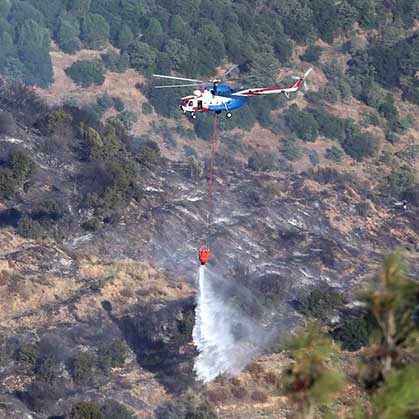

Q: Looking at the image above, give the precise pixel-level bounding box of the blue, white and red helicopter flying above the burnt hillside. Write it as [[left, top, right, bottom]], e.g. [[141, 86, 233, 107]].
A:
[[153, 65, 313, 119]]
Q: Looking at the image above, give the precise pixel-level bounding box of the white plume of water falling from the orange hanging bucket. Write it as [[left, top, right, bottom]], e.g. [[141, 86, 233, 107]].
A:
[[192, 266, 275, 383]]
